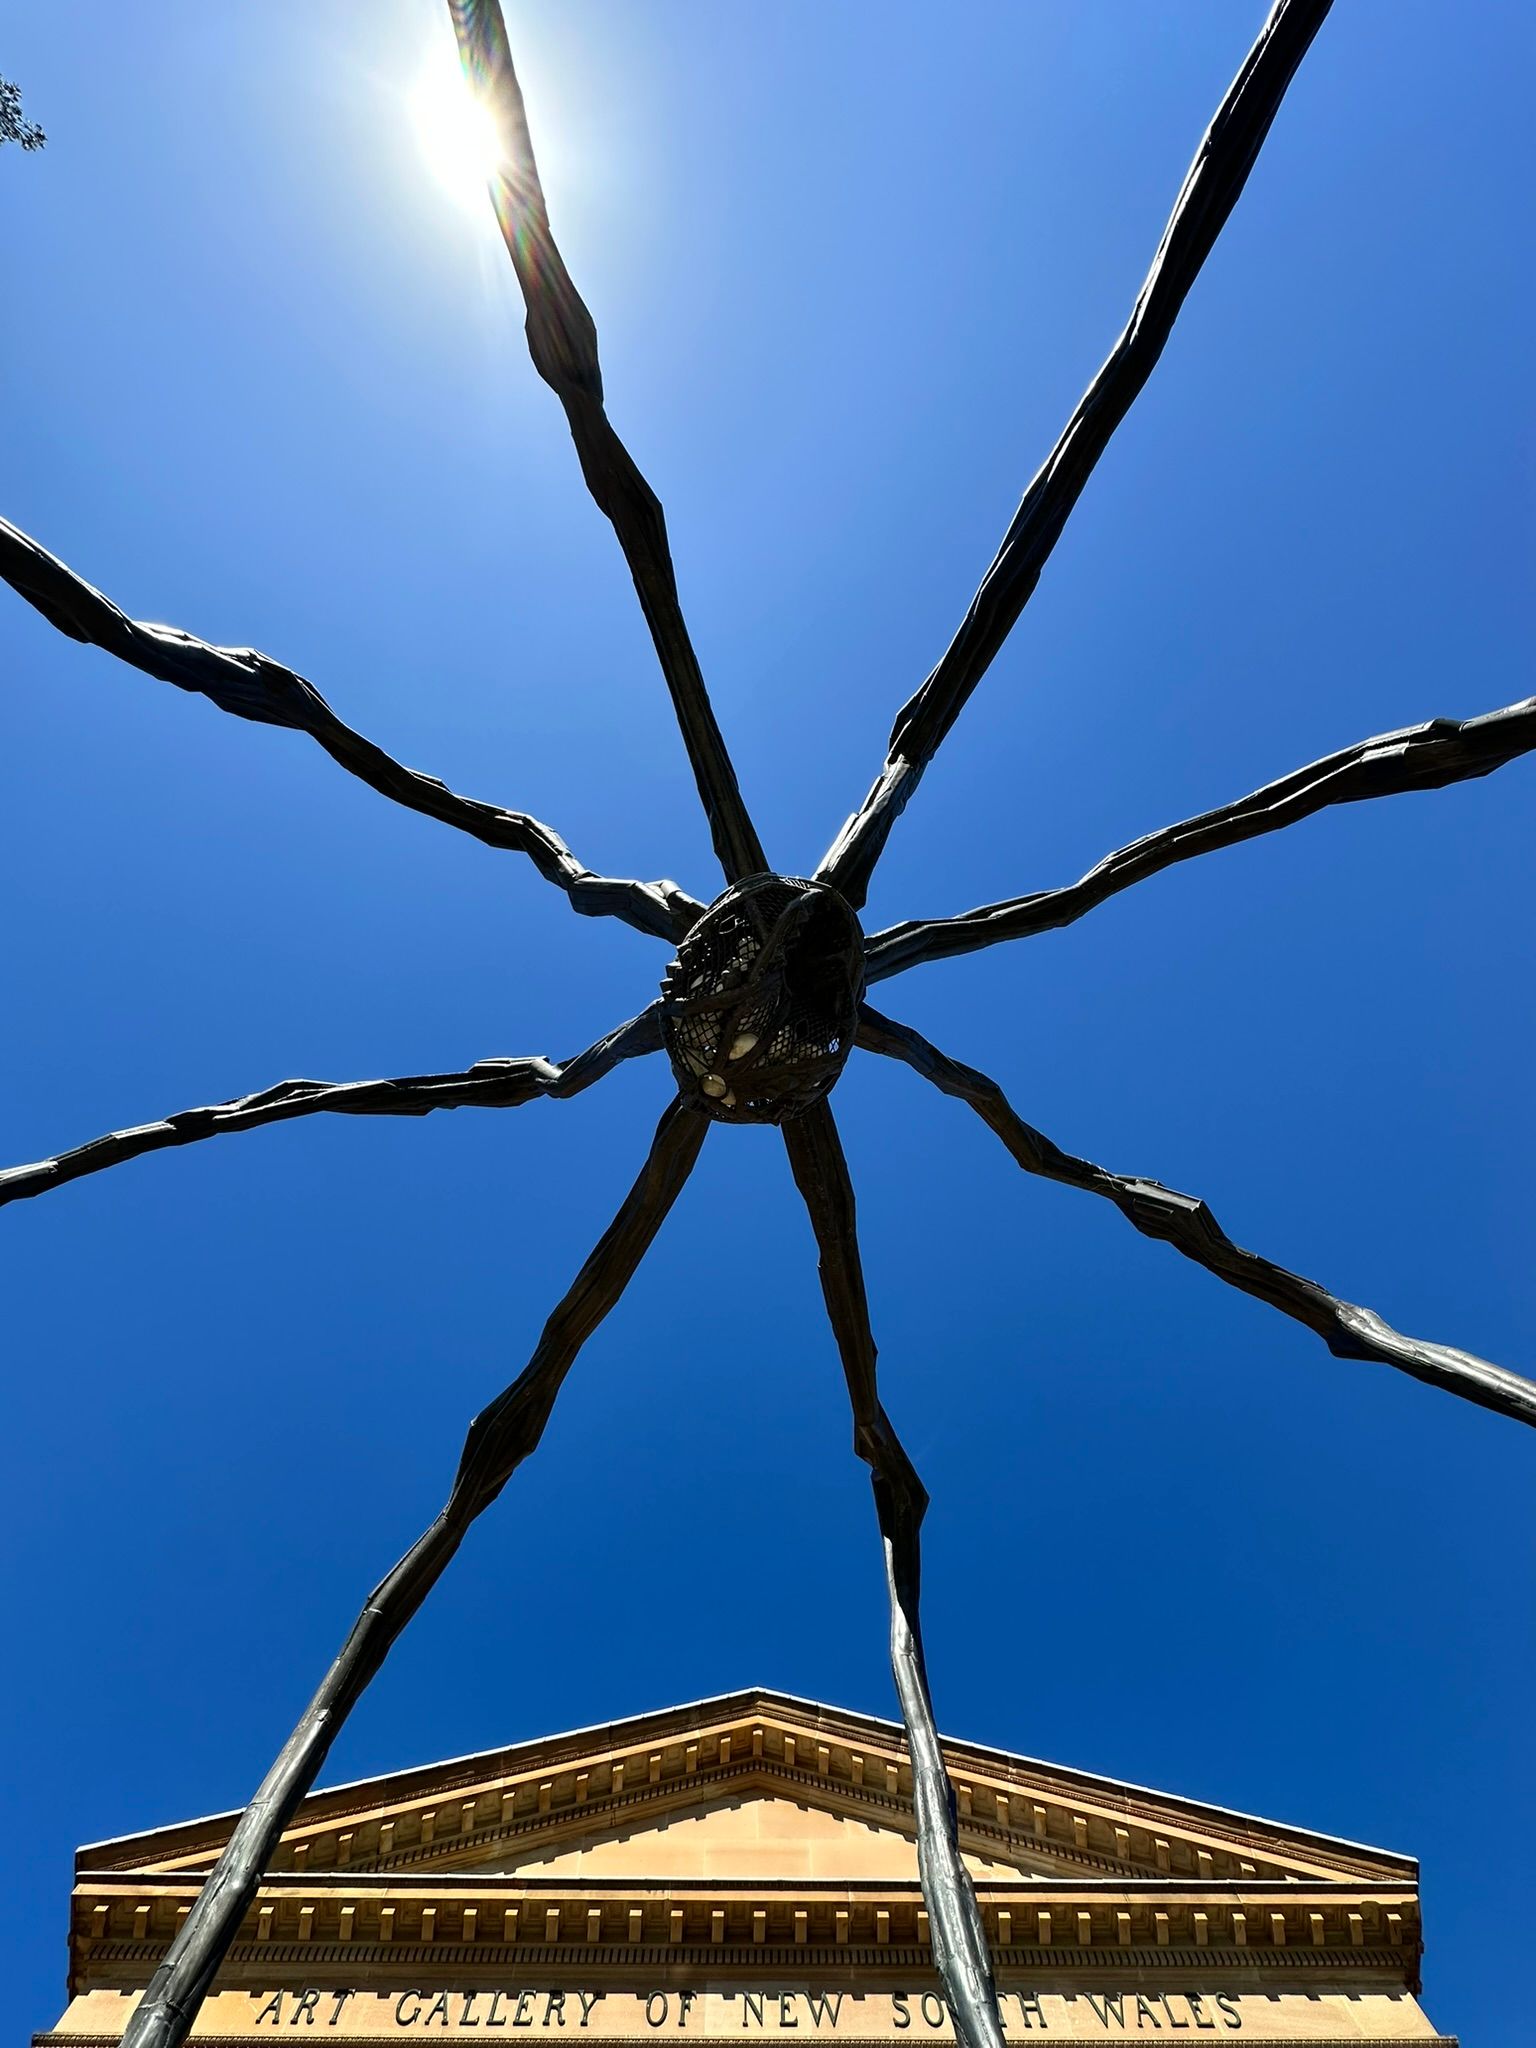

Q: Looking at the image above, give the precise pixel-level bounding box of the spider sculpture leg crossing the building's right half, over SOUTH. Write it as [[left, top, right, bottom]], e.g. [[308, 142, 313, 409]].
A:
[[782, 1102, 1004, 2048]]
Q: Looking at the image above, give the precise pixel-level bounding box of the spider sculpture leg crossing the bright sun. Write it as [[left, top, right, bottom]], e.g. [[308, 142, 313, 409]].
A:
[[449, 0, 768, 881]]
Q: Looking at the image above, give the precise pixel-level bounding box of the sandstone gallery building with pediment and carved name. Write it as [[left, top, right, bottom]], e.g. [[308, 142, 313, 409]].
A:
[[33, 1692, 1454, 2048]]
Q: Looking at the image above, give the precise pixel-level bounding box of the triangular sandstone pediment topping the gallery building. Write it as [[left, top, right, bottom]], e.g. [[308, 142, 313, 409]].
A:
[[76, 1688, 1417, 1884]]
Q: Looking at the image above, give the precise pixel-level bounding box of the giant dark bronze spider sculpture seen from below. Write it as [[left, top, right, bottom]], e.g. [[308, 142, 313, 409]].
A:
[[0, 0, 1536, 2048]]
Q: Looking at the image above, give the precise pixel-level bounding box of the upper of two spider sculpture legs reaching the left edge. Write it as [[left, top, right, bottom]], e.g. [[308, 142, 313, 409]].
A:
[[0, 520, 702, 938]]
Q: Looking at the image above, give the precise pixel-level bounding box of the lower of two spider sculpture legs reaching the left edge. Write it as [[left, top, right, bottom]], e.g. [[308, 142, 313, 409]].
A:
[[0, 1004, 662, 1206]]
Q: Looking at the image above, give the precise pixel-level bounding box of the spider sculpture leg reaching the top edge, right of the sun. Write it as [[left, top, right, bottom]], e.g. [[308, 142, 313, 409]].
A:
[[817, 0, 1331, 909]]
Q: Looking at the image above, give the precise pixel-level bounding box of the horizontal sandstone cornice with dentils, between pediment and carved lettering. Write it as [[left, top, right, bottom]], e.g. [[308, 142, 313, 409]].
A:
[[72, 1872, 1421, 1982]]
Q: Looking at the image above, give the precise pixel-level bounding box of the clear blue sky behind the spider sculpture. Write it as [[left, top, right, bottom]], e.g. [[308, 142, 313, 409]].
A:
[[0, 0, 1536, 2048]]
